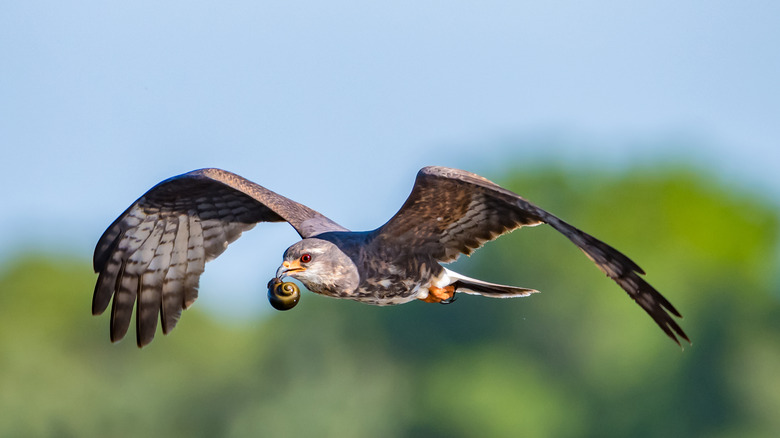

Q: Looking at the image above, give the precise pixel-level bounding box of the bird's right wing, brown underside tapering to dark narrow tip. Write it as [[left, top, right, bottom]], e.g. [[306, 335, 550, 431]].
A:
[[375, 167, 690, 344]]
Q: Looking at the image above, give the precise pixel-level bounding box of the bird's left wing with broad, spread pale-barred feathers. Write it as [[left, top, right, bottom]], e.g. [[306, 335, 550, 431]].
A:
[[92, 169, 345, 347]]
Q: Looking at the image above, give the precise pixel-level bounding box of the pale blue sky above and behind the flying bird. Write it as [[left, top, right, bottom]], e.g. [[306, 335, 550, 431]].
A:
[[0, 1, 780, 313]]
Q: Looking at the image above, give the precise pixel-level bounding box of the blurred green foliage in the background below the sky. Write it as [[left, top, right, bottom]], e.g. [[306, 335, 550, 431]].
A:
[[0, 168, 780, 437]]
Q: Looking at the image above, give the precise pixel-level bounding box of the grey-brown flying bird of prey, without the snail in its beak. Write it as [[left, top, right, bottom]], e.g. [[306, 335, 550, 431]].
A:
[[92, 166, 690, 347]]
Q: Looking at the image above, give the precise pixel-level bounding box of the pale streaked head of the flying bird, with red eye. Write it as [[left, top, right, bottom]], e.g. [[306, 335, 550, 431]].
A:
[[276, 238, 360, 297]]
